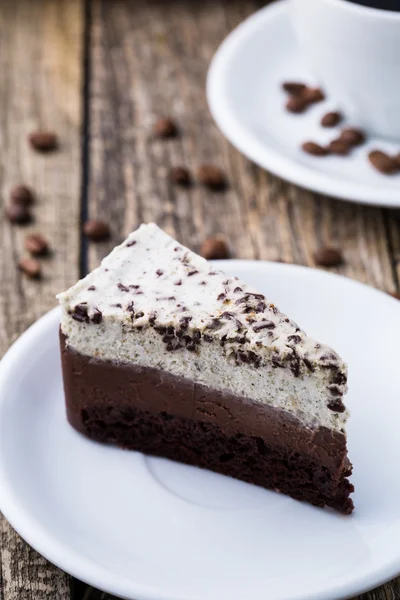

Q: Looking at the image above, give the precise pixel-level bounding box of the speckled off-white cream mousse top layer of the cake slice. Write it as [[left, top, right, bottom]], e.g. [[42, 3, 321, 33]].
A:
[[58, 223, 348, 433]]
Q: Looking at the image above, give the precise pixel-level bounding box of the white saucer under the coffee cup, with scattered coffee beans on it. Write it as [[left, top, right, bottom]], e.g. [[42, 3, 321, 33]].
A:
[[207, 0, 400, 207]]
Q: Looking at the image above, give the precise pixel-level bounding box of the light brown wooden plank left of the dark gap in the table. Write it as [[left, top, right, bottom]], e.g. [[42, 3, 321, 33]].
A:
[[0, 0, 83, 600]]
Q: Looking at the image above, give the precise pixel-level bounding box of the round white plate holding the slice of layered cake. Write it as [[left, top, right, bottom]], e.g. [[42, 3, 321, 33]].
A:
[[0, 260, 400, 600]]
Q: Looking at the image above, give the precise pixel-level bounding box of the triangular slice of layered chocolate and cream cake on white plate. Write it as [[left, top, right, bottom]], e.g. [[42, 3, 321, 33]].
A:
[[58, 224, 353, 513]]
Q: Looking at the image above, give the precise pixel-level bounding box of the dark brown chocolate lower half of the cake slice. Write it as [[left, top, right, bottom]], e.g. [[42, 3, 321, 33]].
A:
[[60, 334, 353, 514]]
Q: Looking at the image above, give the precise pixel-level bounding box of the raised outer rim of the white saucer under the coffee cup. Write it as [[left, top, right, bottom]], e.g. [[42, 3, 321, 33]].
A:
[[206, 0, 400, 208]]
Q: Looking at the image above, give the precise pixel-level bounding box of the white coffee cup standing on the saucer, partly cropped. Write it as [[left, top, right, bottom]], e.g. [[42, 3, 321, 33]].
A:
[[290, 0, 400, 141]]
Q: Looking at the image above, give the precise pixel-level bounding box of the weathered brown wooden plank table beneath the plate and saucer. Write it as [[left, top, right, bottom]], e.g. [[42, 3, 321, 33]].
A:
[[0, 0, 400, 600]]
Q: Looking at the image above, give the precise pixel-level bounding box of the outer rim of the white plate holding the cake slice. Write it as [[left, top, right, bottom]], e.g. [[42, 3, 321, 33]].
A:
[[0, 259, 400, 600]]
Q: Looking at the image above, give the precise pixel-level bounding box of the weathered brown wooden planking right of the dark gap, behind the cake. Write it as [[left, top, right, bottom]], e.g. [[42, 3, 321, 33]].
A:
[[84, 0, 400, 600]]
